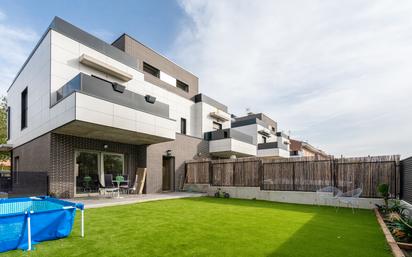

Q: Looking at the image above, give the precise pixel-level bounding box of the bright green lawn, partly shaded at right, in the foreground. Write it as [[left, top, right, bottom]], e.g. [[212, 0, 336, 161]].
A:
[[0, 197, 391, 257]]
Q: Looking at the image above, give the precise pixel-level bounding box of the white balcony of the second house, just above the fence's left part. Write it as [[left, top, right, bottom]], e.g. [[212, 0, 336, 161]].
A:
[[205, 129, 256, 158]]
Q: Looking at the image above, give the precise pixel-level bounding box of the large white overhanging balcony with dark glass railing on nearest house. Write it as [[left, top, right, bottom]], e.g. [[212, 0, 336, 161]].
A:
[[51, 73, 176, 144]]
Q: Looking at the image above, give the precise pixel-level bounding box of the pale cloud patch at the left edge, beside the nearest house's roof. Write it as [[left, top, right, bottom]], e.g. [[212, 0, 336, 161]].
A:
[[0, 10, 39, 95]]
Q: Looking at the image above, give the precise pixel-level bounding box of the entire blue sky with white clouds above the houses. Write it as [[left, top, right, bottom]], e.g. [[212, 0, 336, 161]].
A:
[[0, 0, 412, 158]]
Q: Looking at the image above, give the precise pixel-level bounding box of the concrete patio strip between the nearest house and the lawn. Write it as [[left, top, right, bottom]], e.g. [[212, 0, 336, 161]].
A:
[[68, 192, 207, 209]]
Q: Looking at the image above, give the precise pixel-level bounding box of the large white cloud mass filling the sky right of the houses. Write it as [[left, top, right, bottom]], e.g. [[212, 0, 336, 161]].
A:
[[173, 0, 412, 157]]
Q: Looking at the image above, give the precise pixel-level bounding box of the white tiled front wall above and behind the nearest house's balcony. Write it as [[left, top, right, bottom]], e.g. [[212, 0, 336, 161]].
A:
[[51, 31, 197, 136]]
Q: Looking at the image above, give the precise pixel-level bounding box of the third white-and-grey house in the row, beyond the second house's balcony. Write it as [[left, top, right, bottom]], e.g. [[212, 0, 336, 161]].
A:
[[232, 113, 289, 158]]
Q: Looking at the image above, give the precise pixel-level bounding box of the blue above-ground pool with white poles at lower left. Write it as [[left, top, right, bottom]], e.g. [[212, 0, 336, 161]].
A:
[[0, 196, 84, 252]]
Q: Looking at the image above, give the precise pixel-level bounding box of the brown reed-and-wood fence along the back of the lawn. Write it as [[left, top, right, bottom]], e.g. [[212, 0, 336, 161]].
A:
[[185, 155, 400, 197]]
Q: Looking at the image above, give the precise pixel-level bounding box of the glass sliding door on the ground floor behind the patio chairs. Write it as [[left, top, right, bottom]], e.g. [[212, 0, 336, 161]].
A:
[[75, 150, 124, 195]]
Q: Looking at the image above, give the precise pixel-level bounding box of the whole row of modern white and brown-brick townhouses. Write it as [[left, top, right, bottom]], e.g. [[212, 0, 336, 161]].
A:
[[1, 17, 296, 197]]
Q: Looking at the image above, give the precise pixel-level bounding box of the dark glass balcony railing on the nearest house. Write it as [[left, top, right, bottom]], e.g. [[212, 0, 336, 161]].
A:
[[57, 73, 169, 118]]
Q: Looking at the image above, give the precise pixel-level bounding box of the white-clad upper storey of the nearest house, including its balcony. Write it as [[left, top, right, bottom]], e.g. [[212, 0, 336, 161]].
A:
[[8, 17, 212, 147]]
